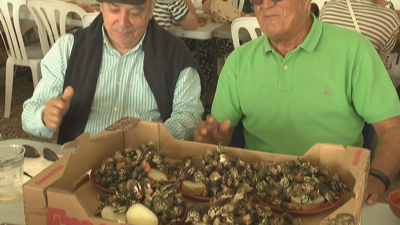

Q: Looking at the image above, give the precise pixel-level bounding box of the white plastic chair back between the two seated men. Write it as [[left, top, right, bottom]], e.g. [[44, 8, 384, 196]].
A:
[[231, 17, 261, 48]]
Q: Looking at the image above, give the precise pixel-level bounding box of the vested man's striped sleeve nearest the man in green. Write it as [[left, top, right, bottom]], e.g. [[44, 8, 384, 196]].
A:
[[164, 67, 204, 140]]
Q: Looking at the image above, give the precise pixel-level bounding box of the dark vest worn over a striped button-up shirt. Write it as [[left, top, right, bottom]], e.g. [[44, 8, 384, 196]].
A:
[[57, 13, 204, 144]]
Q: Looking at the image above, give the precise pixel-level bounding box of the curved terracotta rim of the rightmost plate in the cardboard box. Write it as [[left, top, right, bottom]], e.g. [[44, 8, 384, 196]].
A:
[[253, 190, 344, 216]]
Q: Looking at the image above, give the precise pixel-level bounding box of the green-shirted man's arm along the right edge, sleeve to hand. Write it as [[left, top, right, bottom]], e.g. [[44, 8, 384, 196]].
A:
[[351, 35, 400, 200]]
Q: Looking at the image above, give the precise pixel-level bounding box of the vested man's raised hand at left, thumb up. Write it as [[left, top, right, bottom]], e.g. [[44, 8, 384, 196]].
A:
[[42, 86, 74, 129]]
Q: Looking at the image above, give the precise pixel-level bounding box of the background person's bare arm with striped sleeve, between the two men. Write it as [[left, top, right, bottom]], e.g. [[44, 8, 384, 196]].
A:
[[169, 0, 198, 30]]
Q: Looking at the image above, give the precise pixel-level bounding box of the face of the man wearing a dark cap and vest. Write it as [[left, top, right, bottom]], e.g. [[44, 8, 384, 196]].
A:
[[102, 0, 152, 50]]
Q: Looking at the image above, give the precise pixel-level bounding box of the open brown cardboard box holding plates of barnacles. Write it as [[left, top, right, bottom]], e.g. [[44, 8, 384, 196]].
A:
[[24, 118, 370, 225]]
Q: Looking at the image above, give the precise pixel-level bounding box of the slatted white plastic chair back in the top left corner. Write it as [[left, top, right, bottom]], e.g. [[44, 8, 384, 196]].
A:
[[0, 0, 28, 65]]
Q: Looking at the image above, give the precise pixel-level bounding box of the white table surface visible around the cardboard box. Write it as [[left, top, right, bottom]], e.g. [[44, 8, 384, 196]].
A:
[[0, 139, 400, 225]]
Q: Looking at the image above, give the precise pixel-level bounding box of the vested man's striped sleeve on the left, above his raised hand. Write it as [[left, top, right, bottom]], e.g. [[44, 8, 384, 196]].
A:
[[21, 34, 74, 138]]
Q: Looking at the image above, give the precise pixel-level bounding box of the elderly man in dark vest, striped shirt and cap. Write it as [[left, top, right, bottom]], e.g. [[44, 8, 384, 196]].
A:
[[22, 0, 203, 144]]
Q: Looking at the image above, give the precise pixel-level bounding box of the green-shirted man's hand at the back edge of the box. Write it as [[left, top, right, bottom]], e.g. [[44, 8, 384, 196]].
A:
[[194, 115, 231, 144]]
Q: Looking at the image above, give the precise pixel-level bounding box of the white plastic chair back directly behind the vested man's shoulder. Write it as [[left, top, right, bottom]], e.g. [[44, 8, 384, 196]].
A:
[[27, 0, 86, 54]]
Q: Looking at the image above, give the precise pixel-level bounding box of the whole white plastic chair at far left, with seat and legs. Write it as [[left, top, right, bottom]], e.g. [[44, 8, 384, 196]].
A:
[[0, 0, 43, 118]]
